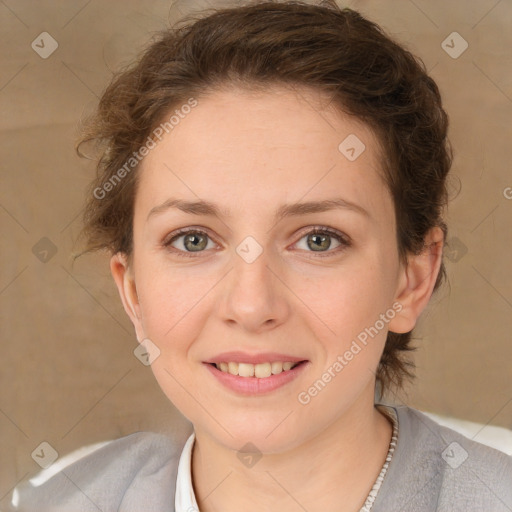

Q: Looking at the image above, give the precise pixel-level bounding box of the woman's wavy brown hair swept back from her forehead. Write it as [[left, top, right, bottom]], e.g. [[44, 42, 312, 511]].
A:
[[76, 0, 452, 400]]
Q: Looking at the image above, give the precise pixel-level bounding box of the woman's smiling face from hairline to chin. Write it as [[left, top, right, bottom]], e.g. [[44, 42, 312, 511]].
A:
[[112, 88, 412, 452]]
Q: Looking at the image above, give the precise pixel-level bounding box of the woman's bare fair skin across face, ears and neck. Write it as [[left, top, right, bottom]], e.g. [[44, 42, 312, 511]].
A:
[[111, 87, 443, 512]]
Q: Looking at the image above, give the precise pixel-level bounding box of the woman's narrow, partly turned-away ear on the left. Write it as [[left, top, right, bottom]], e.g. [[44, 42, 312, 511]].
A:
[[110, 252, 145, 342]]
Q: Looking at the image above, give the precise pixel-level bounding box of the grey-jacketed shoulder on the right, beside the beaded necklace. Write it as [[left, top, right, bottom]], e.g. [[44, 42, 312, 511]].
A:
[[374, 405, 512, 512]]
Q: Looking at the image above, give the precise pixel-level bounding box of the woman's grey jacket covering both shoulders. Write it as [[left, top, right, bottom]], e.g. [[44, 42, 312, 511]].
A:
[[2, 405, 512, 512]]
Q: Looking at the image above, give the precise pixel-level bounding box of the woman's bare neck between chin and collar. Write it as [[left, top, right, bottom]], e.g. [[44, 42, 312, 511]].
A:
[[192, 388, 392, 512]]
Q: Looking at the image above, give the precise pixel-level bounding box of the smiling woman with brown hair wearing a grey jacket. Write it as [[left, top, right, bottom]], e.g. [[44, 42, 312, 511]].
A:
[[9, 2, 512, 512]]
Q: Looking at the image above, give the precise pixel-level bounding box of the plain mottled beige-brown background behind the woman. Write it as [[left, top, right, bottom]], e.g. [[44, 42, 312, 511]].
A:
[[0, 0, 512, 500]]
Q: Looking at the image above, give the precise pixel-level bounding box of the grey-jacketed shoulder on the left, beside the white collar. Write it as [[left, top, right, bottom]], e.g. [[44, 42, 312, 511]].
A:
[[8, 432, 184, 512]]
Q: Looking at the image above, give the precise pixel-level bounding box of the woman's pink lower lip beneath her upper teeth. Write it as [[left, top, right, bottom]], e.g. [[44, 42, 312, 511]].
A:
[[203, 361, 309, 395]]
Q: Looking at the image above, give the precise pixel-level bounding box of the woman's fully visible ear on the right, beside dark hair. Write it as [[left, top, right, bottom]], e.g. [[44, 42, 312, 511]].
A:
[[388, 227, 444, 333]]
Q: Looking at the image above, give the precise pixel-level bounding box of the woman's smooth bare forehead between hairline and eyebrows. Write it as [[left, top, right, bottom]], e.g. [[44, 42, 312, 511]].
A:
[[137, 86, 385, 218]]
